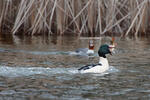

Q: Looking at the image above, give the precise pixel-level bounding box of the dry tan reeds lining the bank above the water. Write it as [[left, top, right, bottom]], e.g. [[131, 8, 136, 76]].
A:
[[0, 0, 150, 36]]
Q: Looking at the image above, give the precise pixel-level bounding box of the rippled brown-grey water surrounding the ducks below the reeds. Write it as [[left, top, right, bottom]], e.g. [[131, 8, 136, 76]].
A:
[[0, 35, 150, 100]]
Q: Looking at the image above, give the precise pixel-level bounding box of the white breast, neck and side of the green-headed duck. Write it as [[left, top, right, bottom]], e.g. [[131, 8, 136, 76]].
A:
[[81, 57, 109, 73]]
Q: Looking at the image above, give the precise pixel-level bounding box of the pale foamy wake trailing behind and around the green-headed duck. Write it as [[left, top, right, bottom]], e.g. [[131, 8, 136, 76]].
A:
[[0, 66, 119, 77]]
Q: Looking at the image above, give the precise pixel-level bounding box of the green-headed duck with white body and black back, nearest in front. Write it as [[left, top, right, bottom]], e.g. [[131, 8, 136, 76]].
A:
[[78, 44, 114, 73]]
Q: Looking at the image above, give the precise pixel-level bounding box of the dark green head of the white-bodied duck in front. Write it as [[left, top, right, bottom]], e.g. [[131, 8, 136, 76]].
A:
[[98, 44, 111, 58]]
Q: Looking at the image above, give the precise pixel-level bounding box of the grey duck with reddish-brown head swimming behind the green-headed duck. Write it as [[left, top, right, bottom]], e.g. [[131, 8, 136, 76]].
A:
[[75, 40, 94, 55]]
